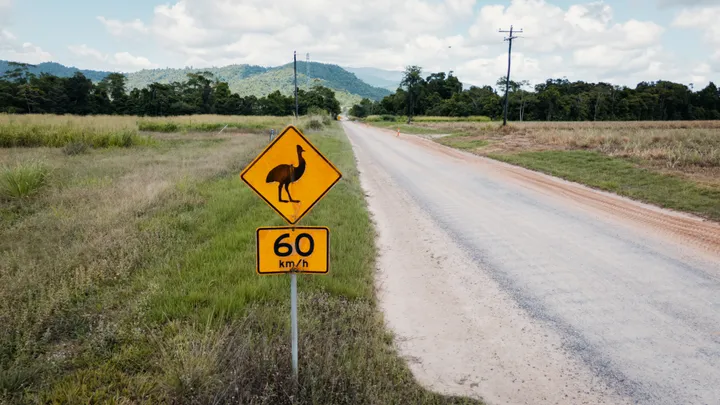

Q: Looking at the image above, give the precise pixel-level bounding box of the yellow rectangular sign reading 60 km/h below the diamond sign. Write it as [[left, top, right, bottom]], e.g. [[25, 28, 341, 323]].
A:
[[256, 226, 330, 274]]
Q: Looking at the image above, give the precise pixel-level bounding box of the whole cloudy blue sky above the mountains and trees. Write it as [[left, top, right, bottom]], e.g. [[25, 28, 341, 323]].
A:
[[0, 0, 720, 85]]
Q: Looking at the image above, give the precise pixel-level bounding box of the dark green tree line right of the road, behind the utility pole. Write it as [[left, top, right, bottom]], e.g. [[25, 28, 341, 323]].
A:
[[350, 66, 720, 121]]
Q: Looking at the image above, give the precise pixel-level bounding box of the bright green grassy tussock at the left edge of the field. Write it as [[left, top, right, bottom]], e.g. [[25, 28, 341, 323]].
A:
[[0, 161, 50, 200]]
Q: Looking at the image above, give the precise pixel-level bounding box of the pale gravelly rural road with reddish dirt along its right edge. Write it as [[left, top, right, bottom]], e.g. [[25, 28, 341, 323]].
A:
[[343, 122, 720, 405]]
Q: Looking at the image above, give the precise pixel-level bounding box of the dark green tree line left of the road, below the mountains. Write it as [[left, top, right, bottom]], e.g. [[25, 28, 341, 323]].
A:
[[0, 63, 340, 116]]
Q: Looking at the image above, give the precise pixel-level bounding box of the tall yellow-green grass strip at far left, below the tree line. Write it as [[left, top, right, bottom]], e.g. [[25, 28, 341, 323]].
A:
[[0, 123, 152, 148]]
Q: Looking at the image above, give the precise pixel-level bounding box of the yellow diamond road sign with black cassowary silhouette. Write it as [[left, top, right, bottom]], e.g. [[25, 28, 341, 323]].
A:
[[240, 125, 342, 224]]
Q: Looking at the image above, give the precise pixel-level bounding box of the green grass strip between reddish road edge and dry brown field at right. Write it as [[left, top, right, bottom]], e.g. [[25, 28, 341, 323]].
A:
[[490, 151, 720, 221]]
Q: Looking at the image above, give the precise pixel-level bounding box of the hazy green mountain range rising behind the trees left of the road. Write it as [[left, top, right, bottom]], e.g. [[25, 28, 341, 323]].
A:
[[0, 60, 394, 107]]
